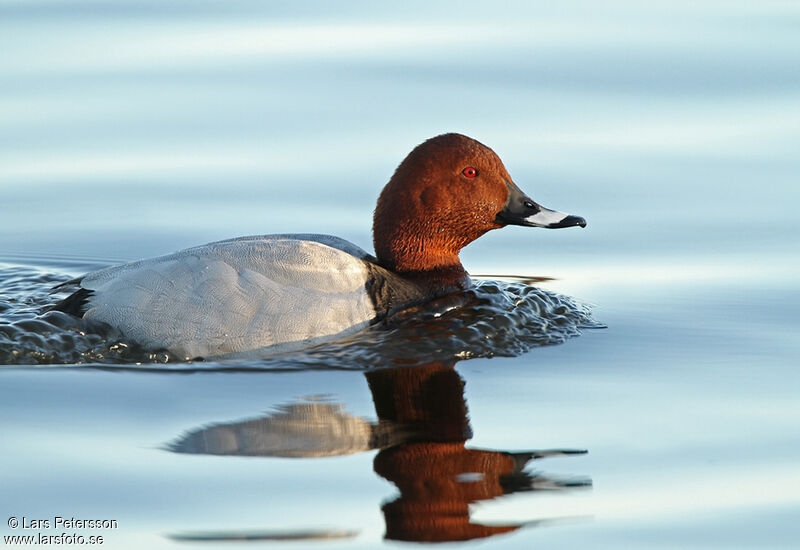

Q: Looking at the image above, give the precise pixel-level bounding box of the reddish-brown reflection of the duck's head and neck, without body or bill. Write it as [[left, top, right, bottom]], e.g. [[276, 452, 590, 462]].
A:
[[367, 364, 519, 542]]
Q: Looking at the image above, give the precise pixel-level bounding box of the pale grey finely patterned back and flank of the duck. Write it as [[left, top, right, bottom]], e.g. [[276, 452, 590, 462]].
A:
[[74, 235, 376, 358]]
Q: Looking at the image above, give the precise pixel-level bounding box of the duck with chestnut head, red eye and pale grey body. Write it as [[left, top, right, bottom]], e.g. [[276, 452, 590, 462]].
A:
[[51, 133, 586, 360]]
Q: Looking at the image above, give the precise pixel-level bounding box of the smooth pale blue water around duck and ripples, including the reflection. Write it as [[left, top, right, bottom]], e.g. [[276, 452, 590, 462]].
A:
[[0, 0, 800, 548]]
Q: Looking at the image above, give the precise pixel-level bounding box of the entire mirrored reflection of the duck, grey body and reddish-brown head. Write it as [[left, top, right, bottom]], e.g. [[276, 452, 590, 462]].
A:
[[170, 363, 591, 542]]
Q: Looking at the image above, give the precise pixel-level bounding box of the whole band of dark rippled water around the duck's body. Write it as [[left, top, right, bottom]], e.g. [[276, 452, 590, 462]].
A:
[[0, 266, 603, 370]]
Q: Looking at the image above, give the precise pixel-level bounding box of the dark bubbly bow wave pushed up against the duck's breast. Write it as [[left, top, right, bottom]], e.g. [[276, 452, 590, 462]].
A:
[[278, 280, 604, 368]]
